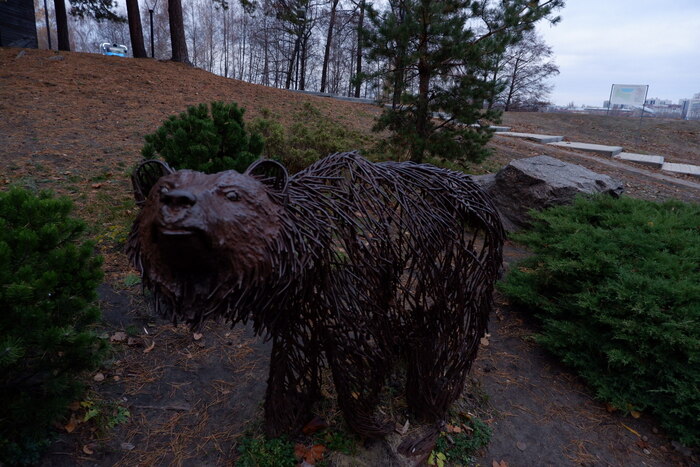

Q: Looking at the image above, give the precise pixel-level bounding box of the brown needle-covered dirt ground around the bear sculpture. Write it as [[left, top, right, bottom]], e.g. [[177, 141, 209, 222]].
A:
[[0, 48, 700, 466]]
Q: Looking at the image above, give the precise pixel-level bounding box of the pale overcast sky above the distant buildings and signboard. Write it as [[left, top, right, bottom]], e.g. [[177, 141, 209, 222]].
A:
[[538, 0, 700, 106]]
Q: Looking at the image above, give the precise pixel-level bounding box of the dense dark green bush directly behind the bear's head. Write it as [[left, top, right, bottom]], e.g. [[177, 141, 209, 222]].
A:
[[141, 102, 264, 173]]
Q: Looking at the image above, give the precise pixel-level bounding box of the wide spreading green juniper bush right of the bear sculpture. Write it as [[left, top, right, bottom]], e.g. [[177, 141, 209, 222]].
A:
[[500, 197, 700, 445]]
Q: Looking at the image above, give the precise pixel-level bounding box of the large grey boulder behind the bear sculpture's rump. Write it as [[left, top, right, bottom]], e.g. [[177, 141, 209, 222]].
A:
[[472, 156, 623, 232]]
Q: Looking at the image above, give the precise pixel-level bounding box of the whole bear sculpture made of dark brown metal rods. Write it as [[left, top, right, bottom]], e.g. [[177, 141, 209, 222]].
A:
[[129, 153, 503, 437]]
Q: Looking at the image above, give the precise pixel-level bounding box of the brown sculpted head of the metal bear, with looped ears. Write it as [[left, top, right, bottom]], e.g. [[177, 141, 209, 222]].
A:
[[128, 161, 287, 325]]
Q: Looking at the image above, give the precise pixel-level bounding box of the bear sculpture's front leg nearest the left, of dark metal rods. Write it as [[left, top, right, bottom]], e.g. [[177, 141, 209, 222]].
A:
[[265, 333, 320, 437]]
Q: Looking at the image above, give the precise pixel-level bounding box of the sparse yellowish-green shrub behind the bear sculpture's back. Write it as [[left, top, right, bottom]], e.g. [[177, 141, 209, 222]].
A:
[[250, 103, 366, 173]]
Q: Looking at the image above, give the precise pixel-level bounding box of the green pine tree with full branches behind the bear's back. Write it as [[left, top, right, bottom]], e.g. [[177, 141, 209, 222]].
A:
[[365, 0, 564, 162]]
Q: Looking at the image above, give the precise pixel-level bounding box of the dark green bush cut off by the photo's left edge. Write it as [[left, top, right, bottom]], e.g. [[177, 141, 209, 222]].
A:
[[0, 188, 105, 465]]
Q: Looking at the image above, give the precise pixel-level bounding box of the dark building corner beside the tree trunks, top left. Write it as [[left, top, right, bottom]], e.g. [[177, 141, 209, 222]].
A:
[[0, 0, 38, 49]]
